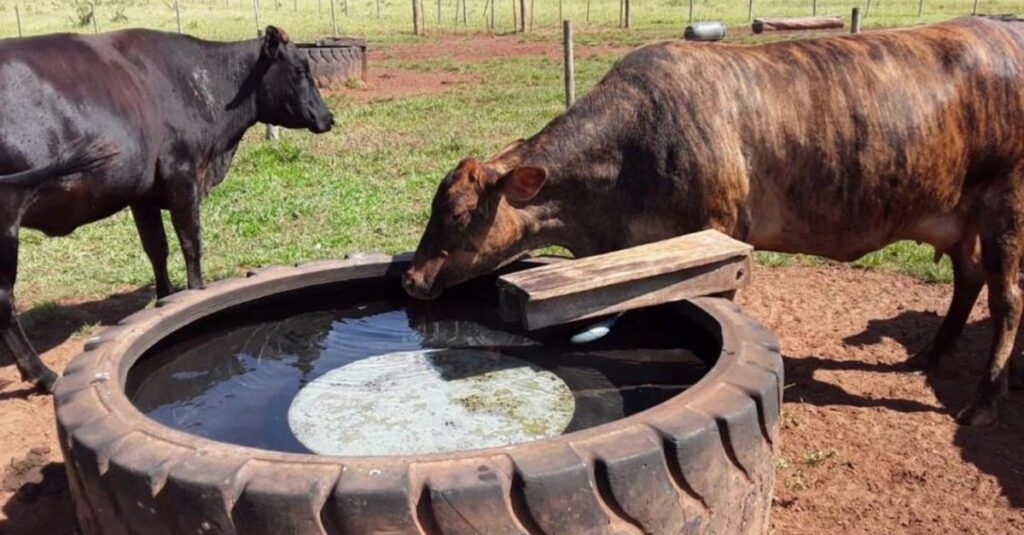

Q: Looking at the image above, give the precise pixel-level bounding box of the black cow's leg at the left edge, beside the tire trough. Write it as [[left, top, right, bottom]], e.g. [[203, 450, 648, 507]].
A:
[[0, 221, 57, 392]]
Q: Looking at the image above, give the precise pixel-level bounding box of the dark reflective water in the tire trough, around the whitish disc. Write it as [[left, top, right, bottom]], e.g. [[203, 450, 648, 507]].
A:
[[128, 280, 707, 452]]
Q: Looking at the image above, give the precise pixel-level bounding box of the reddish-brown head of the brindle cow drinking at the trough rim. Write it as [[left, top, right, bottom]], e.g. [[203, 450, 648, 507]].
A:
[[402, 158, 548, 299]]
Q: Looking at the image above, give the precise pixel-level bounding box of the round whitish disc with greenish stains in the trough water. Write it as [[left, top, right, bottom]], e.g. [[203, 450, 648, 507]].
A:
[[288, 348, 575, 455]]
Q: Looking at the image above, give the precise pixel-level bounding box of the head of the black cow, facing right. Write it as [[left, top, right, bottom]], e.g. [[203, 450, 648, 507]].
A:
[[256, 26, 334, 133]]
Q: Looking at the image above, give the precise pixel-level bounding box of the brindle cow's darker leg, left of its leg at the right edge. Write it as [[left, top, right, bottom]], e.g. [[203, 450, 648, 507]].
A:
[[907, 234, 985, 368]]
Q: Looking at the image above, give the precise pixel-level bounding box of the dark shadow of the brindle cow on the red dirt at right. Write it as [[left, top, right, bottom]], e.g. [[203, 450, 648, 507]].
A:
[[785, 311, 1024, 507]]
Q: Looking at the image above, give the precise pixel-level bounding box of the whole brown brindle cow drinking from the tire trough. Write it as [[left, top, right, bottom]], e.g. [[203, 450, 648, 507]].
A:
[[403, 18, 1024, 424]]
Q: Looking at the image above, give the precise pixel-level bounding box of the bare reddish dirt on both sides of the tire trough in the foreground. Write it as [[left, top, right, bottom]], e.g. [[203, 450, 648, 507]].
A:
[[0, 266, 1024, 535]]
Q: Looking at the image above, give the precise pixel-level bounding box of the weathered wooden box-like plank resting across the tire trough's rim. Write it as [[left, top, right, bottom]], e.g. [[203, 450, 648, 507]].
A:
[[498, 231, 754, 330]]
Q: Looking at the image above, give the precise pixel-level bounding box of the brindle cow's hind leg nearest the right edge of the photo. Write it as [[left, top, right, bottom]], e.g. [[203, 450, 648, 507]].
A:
[[956, 195, 1024, 425]]
